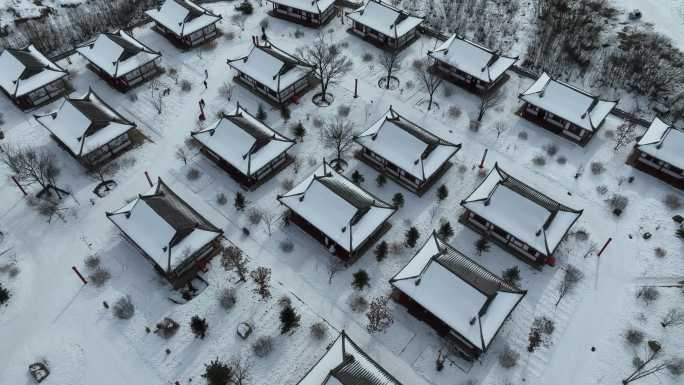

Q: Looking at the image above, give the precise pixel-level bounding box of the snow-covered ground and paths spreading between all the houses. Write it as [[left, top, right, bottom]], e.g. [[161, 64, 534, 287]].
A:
[[0, 0, 684, 385]]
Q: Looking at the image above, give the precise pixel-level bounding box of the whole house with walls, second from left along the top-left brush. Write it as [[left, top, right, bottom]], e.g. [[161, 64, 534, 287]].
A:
[[76, 31, 161, 90]]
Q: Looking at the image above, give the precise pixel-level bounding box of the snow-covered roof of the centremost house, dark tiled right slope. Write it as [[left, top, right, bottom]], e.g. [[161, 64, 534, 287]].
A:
[[278, 162, 396, 253]]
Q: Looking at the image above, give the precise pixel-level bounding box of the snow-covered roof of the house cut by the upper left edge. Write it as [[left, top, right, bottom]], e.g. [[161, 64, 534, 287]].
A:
[[0, 44, 67, 97]]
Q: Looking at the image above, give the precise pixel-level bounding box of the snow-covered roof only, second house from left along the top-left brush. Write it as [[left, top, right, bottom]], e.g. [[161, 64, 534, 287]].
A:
[[76, 31, 161, 78]]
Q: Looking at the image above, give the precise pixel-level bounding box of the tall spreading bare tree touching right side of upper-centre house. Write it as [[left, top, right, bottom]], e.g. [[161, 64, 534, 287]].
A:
[[300, 34, 353, 102]]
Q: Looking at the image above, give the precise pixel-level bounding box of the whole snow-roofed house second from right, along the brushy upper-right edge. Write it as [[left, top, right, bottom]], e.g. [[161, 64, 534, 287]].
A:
[[520, 73, 617, 146]]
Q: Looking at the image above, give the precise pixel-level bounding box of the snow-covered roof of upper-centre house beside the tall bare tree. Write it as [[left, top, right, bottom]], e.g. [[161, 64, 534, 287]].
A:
[[228, 42, 313, 92]]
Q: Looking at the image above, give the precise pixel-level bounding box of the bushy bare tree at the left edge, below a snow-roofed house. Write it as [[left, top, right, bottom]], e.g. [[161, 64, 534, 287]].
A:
[[0, 145, 67, 198]]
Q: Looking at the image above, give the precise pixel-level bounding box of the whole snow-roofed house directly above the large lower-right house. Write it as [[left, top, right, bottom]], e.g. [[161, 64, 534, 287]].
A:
[[459, 164, 582, 269]]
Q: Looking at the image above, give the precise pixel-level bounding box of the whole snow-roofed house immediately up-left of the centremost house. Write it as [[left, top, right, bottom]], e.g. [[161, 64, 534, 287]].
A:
[[191, 105, 295, 189]]
